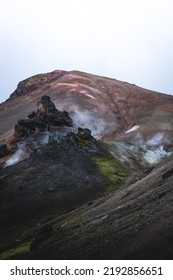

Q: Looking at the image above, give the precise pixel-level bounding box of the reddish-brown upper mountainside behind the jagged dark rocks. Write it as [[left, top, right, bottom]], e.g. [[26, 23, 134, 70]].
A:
[[0, 71, 173, 142]]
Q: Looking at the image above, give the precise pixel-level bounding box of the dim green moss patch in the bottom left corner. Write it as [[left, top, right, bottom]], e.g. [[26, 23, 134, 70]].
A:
[[0, 241, 31, 260]]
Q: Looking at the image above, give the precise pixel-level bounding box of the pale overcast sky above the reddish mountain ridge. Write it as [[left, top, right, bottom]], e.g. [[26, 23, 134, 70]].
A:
[[0, 0, 173, 102]]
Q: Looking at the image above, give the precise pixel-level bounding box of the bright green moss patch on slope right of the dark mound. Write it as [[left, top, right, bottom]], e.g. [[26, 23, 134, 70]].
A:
[[93, 156, 130, 191]]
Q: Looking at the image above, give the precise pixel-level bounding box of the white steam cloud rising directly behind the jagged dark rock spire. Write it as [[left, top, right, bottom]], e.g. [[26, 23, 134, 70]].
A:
[[55, 101, 120, 139]]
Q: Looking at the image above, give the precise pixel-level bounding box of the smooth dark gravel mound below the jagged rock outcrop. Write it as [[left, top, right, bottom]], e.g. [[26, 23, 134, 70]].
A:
[[0, 136, 107, 228]]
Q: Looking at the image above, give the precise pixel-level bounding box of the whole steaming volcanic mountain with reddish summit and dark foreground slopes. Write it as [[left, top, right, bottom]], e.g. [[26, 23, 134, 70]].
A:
[[0, 71, 173, 259]]
